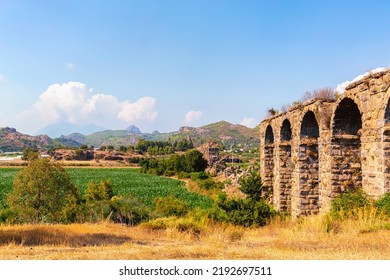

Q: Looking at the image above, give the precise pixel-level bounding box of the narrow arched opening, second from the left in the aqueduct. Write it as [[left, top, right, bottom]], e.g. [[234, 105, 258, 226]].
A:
[[278, 119, 294, 213]]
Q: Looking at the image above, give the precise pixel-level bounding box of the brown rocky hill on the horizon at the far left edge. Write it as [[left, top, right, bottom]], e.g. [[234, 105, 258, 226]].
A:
[[0, 127, 56, 152]]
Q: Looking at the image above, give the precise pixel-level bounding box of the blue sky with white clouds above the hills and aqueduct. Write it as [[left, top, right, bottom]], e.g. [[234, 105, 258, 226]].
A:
[[0, 0, 390, 134]]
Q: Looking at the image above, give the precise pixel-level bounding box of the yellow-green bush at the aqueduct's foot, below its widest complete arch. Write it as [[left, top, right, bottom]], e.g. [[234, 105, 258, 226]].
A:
[[330, 189, 371, 219]]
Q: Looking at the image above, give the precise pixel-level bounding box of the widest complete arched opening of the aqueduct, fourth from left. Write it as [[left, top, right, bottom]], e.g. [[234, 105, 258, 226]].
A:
[[330, 98, 362, 198]]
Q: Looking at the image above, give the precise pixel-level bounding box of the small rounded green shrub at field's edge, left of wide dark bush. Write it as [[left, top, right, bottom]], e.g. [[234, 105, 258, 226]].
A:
[[154, 195, 189, 217]]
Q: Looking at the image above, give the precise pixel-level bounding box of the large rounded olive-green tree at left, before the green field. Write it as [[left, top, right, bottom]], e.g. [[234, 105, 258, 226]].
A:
[[7, 159, 79, 223]]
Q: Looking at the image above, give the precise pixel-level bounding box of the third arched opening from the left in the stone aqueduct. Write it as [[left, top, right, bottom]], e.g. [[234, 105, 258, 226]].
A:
[[298, 111, 320, 215]]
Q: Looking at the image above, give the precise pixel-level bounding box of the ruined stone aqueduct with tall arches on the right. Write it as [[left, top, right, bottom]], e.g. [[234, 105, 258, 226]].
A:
[[260, 70, 390, 216]]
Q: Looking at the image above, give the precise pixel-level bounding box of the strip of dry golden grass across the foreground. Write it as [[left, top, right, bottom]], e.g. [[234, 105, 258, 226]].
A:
[[0, 216, 390, 260]]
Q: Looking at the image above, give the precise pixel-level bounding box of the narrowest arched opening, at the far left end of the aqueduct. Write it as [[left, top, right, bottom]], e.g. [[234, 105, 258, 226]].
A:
[[263, 125, 275, 201]]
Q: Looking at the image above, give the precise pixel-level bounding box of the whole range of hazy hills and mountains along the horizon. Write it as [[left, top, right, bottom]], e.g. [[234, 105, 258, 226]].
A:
[[0, 121, 259, 152]]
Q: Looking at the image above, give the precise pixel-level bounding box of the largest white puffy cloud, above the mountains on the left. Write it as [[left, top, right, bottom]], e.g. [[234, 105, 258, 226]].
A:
[[9, 82, 157, 133]]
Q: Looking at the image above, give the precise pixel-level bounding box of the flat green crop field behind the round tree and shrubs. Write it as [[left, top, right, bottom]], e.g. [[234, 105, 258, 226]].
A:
[[0, 168, 213, 209]]
